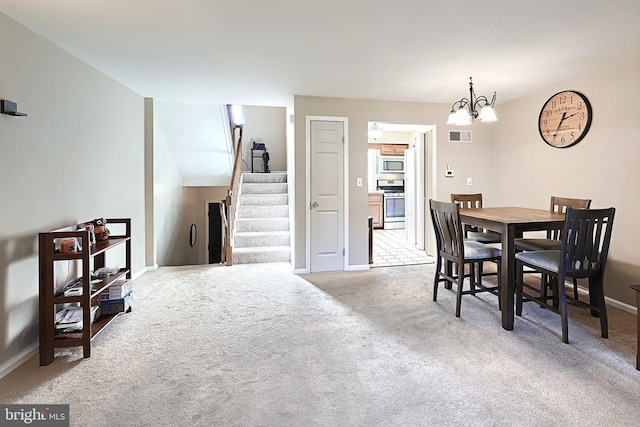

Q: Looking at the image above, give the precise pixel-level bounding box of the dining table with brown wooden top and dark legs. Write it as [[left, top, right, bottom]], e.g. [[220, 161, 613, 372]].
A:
[[460, 207, 564, 331]]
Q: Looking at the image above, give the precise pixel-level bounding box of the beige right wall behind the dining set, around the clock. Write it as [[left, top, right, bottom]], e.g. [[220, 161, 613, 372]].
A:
[[493, 62, 640, 306]]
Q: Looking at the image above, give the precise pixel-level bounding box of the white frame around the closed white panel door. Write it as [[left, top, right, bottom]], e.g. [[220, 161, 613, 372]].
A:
[[305, 116, 349, 273]]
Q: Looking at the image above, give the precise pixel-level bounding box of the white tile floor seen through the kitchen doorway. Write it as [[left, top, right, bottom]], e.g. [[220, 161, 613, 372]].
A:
[[370, 230, 434, 267]]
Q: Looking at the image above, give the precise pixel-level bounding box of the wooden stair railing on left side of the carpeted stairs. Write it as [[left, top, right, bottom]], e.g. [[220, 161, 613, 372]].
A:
[[220, 105, 243, 266]]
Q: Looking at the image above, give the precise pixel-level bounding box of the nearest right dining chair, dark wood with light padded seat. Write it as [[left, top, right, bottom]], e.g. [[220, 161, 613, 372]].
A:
[[515, 208, 615, 343]]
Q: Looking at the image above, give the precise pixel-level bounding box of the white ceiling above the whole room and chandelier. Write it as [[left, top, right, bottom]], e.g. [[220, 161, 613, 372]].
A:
[[0, 0, 640, 181]]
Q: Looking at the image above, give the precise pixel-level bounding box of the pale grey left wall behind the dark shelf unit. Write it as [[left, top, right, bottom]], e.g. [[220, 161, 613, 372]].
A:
[[0, 13, 145, 376]]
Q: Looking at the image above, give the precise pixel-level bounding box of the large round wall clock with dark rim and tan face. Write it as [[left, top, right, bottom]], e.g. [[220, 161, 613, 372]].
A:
[[538, 90, 591, 148]]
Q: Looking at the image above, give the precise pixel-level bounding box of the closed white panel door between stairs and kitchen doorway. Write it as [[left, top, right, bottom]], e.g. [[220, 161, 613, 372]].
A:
[[309, 120, 345, 272]]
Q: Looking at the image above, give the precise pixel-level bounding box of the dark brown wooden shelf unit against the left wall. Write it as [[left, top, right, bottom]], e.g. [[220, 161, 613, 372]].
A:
[[38, 218, 131, 366]]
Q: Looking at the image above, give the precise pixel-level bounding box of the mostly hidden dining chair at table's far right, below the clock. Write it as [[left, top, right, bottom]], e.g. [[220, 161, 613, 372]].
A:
[[514, 196, 591, 304]]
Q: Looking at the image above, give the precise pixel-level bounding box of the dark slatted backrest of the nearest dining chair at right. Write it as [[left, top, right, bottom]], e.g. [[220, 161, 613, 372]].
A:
[[561, 208, 616, 277]]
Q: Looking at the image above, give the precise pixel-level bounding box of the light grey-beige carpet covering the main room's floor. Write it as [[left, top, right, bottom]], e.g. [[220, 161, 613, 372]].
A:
[[0, 264, 640, 427]]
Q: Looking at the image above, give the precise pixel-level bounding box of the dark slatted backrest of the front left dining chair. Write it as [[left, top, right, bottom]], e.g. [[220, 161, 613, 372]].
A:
[[429, 199, 464, 262]]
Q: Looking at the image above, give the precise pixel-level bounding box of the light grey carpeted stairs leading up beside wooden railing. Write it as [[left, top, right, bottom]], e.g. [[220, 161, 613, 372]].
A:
[[233, 172, 291, 264]]
